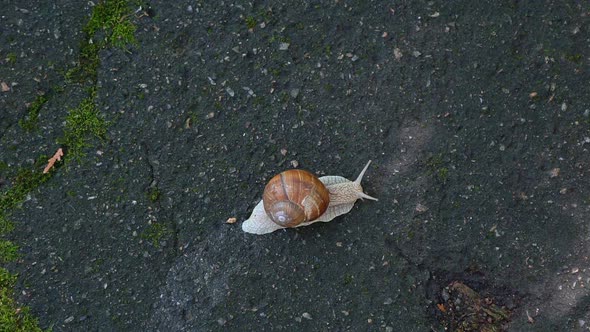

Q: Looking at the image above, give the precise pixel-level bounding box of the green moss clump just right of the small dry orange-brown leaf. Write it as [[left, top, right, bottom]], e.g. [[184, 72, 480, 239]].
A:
[[58, 89, 108, 160]]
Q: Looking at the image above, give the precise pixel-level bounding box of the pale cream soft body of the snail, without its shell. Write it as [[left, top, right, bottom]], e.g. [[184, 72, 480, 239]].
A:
[[242, 160, 377, 234]]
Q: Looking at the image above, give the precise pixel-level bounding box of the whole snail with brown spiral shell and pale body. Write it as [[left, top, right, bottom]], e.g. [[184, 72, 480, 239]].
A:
[[242, 160, 377, 234]]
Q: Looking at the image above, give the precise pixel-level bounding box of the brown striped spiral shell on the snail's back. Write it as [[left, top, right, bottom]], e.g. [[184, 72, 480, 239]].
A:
[[262, 169, 330, 227]]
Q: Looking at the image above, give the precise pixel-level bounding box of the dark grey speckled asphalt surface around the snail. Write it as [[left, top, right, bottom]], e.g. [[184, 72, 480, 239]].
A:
[[0, 0, 590, 331]]
